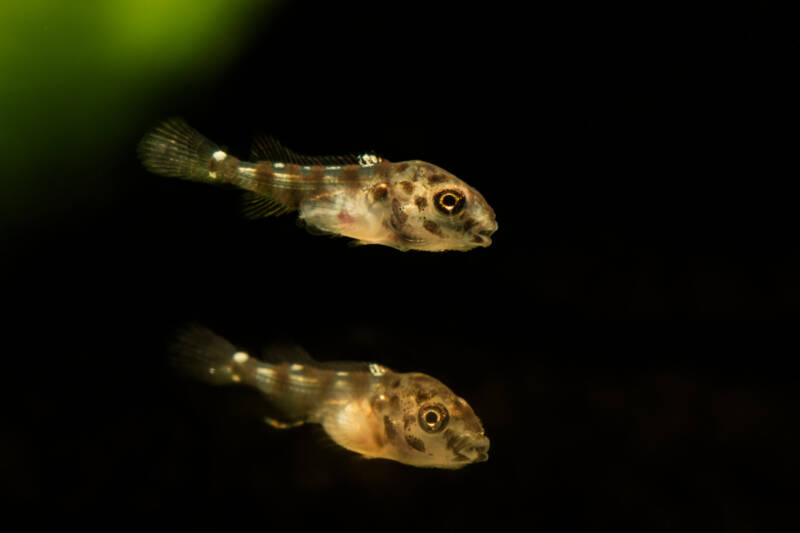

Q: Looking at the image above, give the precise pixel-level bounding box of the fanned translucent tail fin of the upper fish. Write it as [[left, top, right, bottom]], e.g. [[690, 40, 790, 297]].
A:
[[137, 118, 219, 181]]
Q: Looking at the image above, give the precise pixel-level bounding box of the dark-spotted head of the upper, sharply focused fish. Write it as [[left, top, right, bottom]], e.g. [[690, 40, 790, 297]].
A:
[[387, 161, 497, 251]]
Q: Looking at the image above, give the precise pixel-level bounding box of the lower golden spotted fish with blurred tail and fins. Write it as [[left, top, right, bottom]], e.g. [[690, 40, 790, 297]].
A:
[[173, 326, 489, 469]]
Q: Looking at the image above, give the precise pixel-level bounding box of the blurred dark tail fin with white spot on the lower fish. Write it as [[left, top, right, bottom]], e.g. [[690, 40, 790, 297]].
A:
[[170, 325, 252, 385]]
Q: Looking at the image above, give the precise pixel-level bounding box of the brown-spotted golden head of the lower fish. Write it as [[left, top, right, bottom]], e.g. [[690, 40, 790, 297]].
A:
[[375, 373, 489, 469]]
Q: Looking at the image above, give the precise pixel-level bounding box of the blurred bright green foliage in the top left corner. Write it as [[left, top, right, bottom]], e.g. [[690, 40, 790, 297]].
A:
[[0, 0, 275, 235]]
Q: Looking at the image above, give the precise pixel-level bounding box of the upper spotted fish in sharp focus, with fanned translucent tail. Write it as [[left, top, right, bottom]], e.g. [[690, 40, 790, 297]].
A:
[[139, 119, 497, 252]]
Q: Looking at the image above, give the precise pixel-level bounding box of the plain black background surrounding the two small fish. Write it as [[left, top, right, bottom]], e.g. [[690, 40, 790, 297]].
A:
[[3, 2, 800, 531]]
